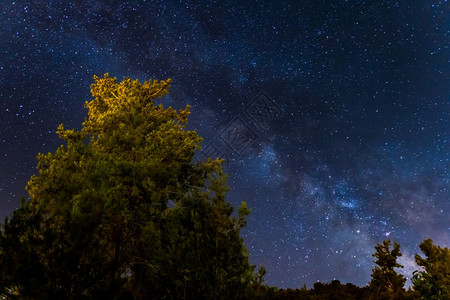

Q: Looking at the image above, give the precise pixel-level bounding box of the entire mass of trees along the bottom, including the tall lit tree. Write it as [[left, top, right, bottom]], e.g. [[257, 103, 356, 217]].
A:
[[0, 74, 450, 300]]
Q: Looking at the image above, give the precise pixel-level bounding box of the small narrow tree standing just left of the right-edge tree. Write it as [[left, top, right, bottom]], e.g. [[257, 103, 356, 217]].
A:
[[369, 240, 406, 299]]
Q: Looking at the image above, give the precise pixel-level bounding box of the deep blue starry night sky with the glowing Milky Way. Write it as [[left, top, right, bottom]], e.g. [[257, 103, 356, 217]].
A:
[[0, 0, 450, 288]]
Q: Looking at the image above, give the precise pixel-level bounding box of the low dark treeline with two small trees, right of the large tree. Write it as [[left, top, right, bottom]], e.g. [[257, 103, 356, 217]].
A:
[[253, 239, 450, 300]]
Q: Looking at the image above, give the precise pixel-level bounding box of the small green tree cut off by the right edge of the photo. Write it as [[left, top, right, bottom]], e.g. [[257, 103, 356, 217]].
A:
[[412, 239, 450, 300]]
